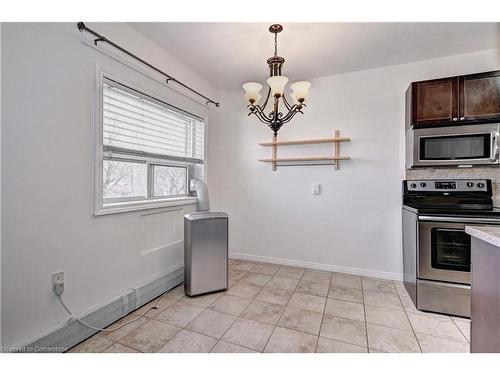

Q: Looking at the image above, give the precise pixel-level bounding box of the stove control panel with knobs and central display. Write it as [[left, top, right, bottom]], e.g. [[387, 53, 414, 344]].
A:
[[404, 179, 488, 192]]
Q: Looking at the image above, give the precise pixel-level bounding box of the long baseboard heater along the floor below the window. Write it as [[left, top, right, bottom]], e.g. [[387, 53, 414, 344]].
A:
[[4, 266, 184, 353]]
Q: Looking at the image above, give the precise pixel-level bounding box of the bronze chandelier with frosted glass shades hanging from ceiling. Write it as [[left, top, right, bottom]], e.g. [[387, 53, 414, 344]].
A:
[[242, 24, 311, 137]]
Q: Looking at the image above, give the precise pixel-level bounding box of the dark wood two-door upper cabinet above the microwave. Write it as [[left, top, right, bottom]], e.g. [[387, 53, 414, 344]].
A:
[[406, 70, 500, 127]]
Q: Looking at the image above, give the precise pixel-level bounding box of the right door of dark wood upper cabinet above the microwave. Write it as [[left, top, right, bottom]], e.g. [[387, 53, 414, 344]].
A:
[[459, 71, 500, 121]]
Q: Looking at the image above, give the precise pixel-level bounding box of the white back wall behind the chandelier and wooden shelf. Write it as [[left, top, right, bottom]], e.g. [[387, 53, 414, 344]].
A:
[[208, 50, 497, 278]]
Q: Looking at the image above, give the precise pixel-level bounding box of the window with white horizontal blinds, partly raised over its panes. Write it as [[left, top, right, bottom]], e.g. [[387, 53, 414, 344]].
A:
[[96, 77, 205, 214]]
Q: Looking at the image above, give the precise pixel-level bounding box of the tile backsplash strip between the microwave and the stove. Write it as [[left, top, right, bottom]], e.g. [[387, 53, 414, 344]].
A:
[[406, 167, 500, 207]]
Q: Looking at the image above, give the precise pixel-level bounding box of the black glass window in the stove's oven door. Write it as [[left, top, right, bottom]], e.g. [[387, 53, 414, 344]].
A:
[[431, 228, 470, 272]]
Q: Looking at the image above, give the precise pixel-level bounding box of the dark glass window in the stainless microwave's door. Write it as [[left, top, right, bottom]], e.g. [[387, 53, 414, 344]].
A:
[[420, 133, 491, 160]]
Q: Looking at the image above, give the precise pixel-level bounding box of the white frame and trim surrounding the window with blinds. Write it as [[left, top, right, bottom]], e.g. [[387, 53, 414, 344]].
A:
[[94, 65, 207, 216]]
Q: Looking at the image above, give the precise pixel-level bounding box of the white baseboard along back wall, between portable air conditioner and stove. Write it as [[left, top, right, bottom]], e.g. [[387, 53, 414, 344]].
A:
[[229, 252, 403, 281]]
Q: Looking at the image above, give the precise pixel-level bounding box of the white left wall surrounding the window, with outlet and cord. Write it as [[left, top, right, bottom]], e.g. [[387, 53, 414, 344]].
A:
[[1, 23, 216, 346]]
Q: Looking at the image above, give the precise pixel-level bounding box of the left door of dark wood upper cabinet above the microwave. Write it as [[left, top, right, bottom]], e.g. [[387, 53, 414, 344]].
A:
[[412, 77, 458, 125]]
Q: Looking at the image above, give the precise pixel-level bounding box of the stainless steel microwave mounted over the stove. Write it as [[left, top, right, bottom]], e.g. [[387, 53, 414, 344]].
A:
[[406, 124, 500, 169]]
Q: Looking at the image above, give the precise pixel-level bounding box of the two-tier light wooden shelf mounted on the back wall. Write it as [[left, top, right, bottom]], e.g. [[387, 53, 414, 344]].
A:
[[259, 130, 351, 171]]
